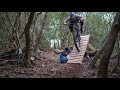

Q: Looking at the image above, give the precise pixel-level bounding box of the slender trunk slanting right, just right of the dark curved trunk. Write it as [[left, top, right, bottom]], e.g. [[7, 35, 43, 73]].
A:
[[33, 12, 47, 53]]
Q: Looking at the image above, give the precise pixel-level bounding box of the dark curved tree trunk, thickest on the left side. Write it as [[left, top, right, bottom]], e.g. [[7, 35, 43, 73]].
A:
[[24, 12, 35, 67]]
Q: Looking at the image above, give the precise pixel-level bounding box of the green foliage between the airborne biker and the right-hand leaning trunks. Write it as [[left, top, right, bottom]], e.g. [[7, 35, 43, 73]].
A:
[[84, 12, 113, 48]]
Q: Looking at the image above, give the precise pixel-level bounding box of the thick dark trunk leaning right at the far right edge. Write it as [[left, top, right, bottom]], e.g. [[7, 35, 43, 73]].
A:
[[97, 12, 120, 78]]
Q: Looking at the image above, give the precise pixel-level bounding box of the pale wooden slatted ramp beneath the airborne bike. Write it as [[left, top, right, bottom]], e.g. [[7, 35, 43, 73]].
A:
[[67, 35, 90, 63]]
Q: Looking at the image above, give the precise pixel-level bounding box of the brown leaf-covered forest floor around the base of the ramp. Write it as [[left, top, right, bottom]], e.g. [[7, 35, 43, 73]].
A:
[[0, 51, 120, 78]]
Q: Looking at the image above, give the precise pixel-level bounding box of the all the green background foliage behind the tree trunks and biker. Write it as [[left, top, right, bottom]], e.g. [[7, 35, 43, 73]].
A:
[[0, 12, 115, 48]]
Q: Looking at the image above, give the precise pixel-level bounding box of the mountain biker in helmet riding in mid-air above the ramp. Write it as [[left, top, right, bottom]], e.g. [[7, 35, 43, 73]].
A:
[[64, 12, 84, 34]]
